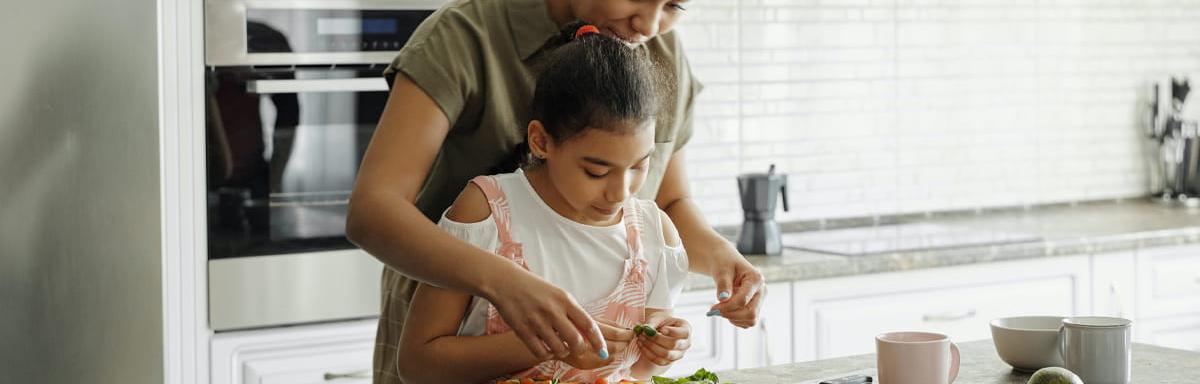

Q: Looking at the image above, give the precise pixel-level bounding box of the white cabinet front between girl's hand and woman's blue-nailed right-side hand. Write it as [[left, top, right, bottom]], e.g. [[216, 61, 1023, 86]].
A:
[[665, 289, 737, 377]]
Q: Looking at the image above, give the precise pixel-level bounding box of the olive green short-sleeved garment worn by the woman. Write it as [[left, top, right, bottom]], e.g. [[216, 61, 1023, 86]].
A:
[[374, 0, 702, 384]]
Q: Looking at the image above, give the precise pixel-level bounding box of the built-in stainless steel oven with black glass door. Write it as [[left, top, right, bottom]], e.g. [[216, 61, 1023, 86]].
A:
[[204, 0, 442, 331]]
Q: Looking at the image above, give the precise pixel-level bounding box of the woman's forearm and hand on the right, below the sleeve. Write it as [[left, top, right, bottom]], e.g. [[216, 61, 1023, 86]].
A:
[[655, 150, 767, 328]]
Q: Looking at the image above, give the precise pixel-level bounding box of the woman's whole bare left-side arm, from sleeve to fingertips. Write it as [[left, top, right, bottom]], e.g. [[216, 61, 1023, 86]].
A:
[[346, 74, 604, 359]]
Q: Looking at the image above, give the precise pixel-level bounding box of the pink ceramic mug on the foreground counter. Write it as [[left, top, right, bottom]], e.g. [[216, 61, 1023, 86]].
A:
[[875, 331, 959, 384]]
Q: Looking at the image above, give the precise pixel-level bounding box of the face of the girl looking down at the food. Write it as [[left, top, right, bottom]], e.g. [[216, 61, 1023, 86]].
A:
[[529, 119, 654, 226]]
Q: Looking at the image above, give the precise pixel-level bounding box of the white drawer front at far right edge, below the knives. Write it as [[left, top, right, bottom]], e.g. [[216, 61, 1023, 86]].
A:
[[1138, 246, 1200, 318]]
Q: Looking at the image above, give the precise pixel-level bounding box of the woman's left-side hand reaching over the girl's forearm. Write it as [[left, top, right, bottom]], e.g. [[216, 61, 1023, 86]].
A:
[[484, 268, 607, 360]]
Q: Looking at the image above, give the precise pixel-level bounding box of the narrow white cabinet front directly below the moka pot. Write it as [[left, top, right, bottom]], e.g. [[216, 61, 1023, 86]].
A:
[[726, 282, 793, 370]]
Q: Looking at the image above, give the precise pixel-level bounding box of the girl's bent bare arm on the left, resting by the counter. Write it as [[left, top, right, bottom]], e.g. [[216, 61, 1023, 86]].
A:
[[396, 283, 542, 383]]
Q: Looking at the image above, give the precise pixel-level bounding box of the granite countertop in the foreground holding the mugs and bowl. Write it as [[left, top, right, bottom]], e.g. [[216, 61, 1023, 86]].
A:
[[718, 340, 1200, 384]]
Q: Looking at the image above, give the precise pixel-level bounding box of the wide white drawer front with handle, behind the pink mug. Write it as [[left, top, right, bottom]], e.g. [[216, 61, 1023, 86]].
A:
[[792, 256, 1092, 361]]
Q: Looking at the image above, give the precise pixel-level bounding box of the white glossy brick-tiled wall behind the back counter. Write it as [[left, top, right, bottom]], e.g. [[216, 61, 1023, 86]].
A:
[[679, 0, 1200, 224]]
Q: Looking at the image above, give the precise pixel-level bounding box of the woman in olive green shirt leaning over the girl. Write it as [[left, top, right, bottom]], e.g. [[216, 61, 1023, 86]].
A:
[[347, 0, 766, 383]]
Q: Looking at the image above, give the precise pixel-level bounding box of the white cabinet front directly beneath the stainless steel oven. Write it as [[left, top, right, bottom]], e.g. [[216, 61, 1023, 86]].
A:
[[211, 319, 378, 384]]
